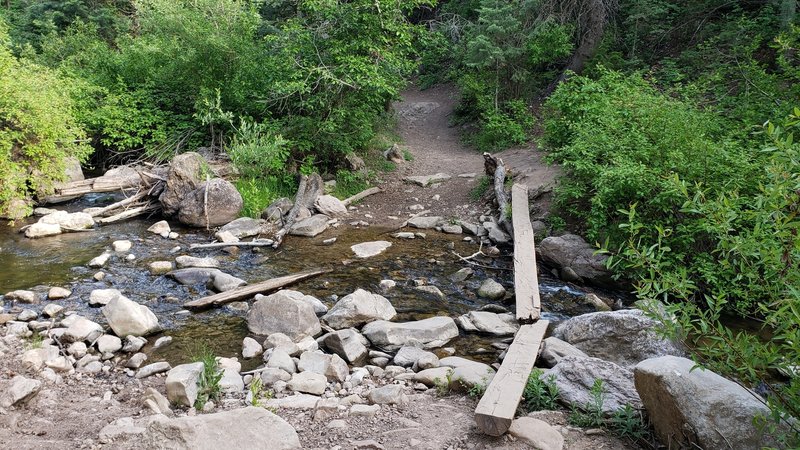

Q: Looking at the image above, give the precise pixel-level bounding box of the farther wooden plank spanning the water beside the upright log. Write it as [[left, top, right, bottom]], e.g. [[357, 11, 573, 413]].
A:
[[511, 184, 542, 323]]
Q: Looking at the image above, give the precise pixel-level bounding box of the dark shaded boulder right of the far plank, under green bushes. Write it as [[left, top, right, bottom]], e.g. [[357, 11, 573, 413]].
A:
[[536, 234, 613, 285]]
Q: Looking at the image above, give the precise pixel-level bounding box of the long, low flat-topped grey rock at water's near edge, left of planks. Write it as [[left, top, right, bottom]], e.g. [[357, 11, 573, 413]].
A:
[[361, 316, 458, 351]]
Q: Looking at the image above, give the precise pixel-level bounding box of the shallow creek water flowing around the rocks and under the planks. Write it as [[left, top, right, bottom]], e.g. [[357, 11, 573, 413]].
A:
[[0, 195, 612, 370]]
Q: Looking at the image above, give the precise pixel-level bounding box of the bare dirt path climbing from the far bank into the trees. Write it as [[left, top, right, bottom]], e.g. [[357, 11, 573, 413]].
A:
[[354, 85, 558, 226]]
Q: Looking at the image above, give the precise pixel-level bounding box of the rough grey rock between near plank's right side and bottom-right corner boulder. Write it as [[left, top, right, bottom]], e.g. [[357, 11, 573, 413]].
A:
[[543, 356, 642, 414]]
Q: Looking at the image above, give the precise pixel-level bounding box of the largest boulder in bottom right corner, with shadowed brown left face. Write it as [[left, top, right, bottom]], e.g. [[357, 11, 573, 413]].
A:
[[634, 356, 779, 449]]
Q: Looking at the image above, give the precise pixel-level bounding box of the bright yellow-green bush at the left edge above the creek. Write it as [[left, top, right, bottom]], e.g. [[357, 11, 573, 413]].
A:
[[0, 20, 91, 217]]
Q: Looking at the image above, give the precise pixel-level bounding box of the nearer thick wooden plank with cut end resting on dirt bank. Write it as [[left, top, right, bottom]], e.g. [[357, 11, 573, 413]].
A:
[[475, 320, 548, 436]]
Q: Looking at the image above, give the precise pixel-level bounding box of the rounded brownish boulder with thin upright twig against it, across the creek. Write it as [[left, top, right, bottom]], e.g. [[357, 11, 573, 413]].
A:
[[178, 178, 244, 227]]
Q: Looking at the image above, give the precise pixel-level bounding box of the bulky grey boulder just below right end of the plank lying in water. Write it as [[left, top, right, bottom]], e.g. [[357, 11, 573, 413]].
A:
[[247, 291, 322, 342]]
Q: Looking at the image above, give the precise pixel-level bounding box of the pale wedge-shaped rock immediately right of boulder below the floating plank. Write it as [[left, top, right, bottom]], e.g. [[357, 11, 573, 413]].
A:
[[322, 289, 397, 330]]
